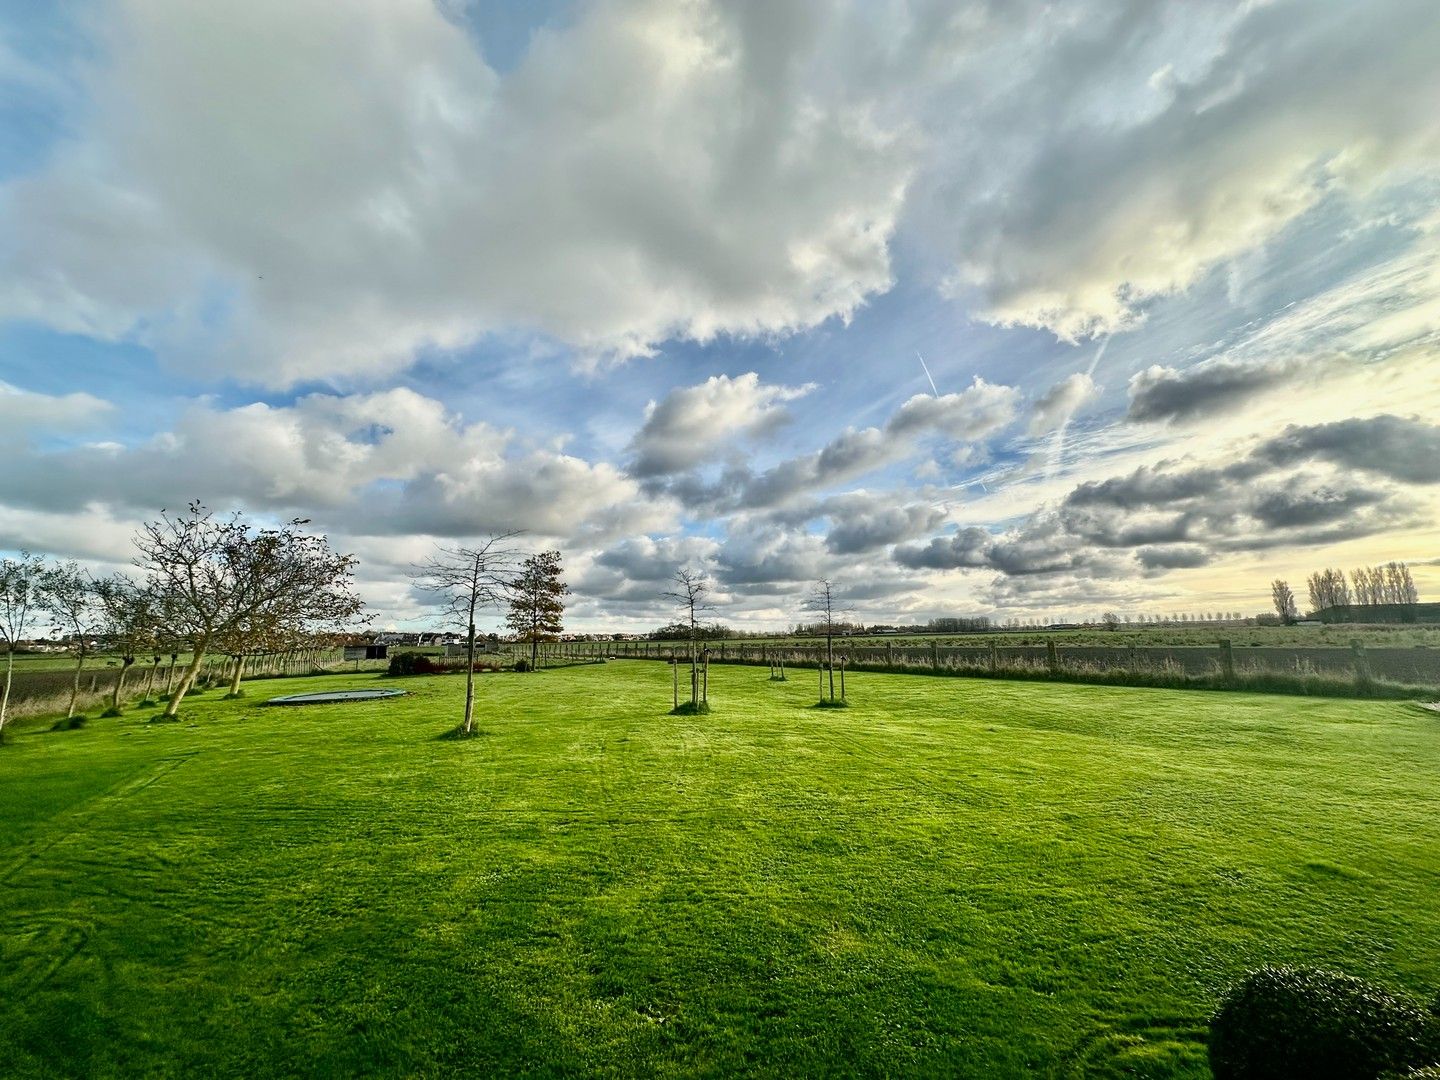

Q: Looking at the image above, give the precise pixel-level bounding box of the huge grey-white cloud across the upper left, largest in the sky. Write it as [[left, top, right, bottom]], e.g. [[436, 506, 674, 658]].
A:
[[0, 0, 913, 384]]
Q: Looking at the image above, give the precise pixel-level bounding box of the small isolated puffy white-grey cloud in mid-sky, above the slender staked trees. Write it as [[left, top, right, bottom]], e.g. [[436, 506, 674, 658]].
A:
[[626, 372, 815, 477]]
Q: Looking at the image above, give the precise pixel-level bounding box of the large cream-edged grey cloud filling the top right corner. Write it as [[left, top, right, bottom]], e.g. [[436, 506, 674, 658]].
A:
[[916, 0, 1440, 340]]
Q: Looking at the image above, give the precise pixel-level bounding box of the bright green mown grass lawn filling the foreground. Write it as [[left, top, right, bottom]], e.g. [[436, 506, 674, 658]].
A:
[[0, 662, 1440, 1077]]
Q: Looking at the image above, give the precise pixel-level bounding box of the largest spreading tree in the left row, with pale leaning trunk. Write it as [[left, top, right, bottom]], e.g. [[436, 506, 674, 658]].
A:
[[135, 503, 360, 720]]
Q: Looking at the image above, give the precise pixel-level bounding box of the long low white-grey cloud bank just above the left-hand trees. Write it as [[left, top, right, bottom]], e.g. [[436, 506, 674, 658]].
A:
[[0, 389, 668, 540]]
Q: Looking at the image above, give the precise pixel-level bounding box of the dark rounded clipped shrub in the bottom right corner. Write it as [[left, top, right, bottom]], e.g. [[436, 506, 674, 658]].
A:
[[1210, 968, 1440, 1080]]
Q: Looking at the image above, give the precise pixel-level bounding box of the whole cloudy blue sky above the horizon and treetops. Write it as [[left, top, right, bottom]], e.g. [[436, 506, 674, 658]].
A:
[[0, 0, 1440, 631]]
